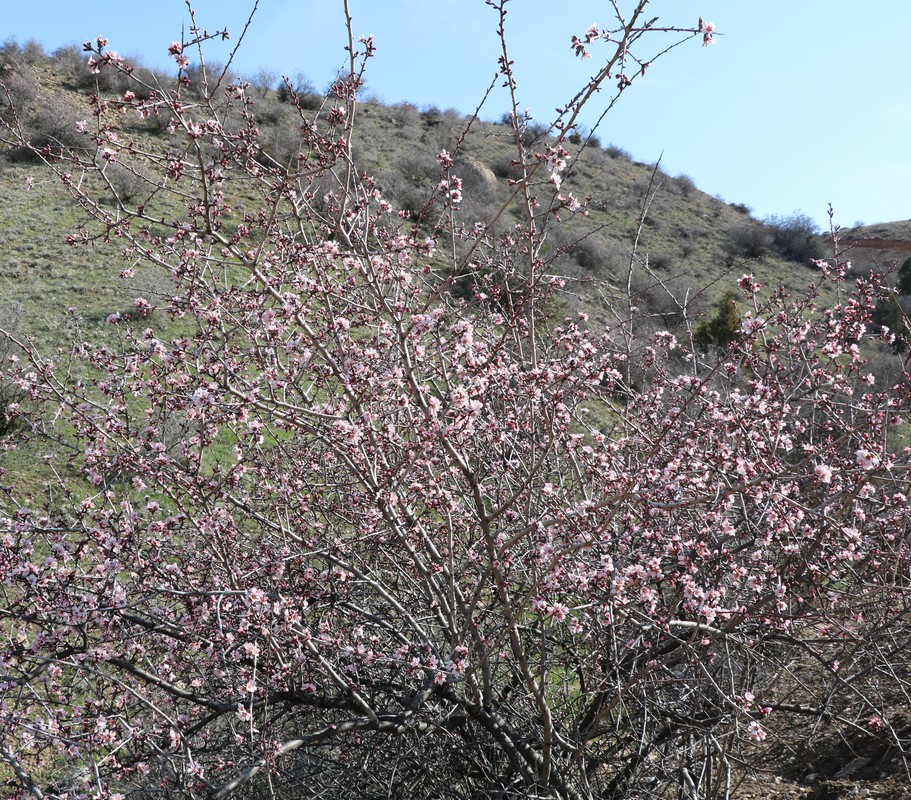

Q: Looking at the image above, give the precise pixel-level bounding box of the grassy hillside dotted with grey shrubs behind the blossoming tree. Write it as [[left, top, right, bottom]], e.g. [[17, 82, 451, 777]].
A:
[[0, 42, 911, 432]]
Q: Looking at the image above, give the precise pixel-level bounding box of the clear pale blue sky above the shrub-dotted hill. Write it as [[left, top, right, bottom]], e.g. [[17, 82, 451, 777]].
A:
[[0, 0, 911, 226]]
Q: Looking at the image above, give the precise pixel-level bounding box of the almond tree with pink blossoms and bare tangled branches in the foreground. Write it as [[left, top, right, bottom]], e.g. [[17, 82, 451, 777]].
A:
[[0, 0, 911, 800]]
